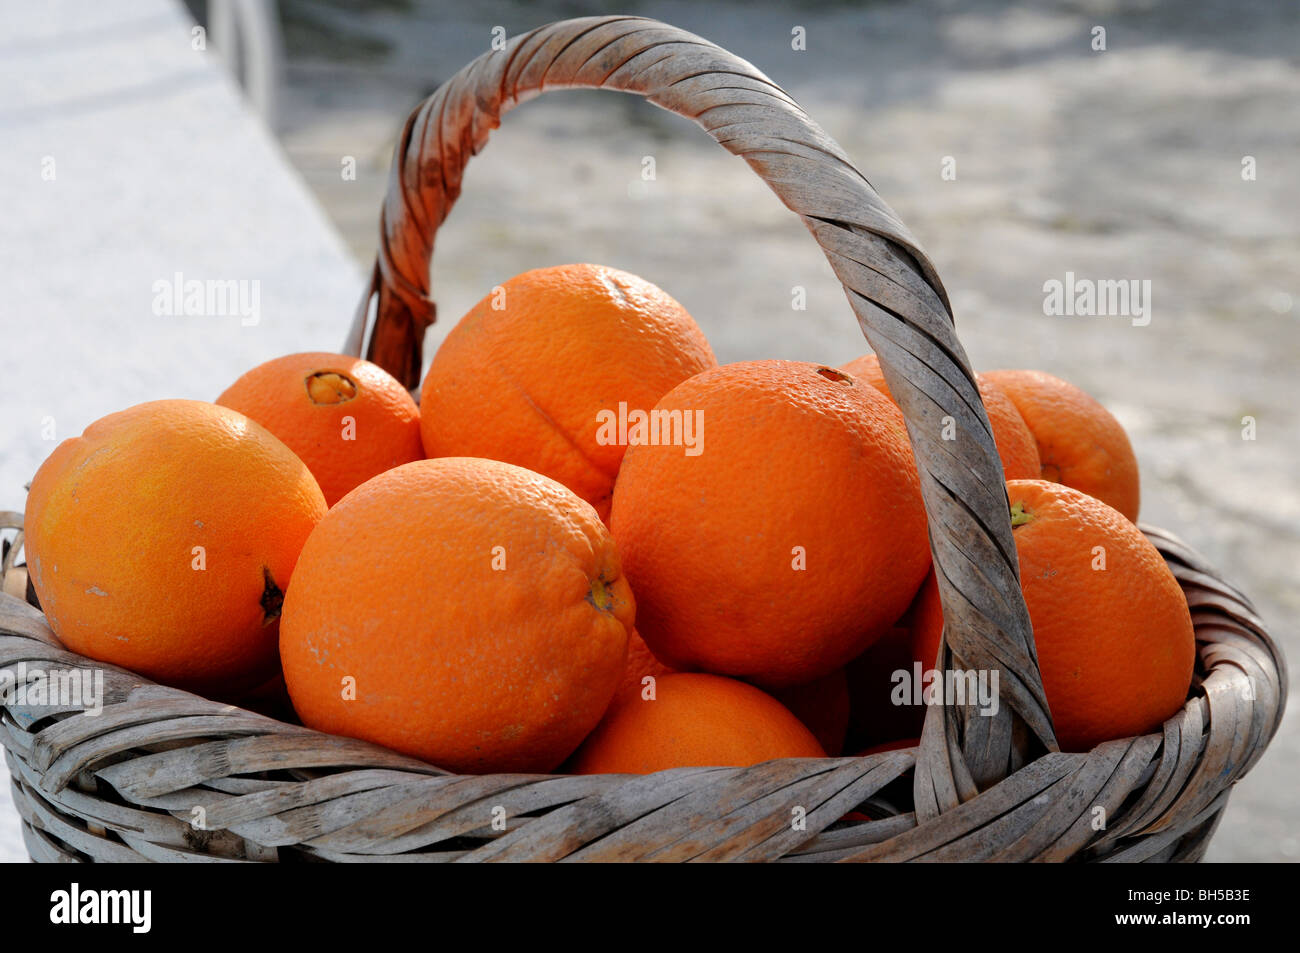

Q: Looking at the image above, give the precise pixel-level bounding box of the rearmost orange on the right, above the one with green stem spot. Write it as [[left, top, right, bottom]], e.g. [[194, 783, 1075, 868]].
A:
[[984, 371, 1140, 521]]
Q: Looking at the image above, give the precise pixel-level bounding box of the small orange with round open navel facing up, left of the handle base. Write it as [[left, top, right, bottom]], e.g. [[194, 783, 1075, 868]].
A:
[[217, 352, 424, 506]]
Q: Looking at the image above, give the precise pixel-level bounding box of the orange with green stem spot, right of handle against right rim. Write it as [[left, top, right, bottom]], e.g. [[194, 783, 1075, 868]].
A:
[[1008, 480, 1196, 751]]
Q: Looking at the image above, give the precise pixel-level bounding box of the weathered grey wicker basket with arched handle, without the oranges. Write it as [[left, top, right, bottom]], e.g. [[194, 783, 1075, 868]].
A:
[[0, 17, 1286, 861]]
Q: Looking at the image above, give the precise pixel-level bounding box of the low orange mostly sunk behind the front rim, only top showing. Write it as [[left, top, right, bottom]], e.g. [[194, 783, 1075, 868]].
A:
[[571, 672, 826, 775]]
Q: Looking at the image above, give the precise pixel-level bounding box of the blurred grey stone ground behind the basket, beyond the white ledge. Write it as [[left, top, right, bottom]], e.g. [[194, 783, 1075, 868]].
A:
[[266, 0, 1300, 861]]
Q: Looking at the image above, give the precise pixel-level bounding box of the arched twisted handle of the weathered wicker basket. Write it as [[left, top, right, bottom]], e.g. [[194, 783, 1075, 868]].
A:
[[347, 17, 1056, 795]]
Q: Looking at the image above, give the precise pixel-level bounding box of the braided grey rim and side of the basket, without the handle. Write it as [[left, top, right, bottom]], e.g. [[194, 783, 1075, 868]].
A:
[[0, 514, 1287, 862]]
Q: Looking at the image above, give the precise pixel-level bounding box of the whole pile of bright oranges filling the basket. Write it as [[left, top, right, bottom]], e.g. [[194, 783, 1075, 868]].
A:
[[26, 265, 1195, 772]]
